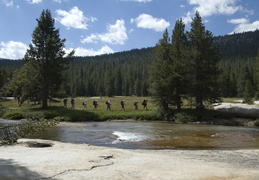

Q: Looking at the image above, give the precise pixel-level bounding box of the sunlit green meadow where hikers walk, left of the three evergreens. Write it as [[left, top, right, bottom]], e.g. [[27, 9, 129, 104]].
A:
[[0, 96, 157, 121]]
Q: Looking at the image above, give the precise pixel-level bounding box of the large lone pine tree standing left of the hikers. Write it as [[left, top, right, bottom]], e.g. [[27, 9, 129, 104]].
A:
[[24, 10, 74, 108]]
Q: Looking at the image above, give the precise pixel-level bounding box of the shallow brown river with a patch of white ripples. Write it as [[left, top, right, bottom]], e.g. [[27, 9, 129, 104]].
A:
[[0, 121, 259, 149]]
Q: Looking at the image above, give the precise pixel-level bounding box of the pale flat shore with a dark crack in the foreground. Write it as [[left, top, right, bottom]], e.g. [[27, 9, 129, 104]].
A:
[[0, 139, 259, 180]]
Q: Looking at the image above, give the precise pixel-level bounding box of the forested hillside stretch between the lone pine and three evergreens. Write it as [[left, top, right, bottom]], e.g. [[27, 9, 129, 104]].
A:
[[66, 48, 153, 97]]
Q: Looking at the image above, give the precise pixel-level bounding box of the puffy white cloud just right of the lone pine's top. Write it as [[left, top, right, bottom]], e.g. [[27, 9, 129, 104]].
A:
[[56, 6, 97, 29]]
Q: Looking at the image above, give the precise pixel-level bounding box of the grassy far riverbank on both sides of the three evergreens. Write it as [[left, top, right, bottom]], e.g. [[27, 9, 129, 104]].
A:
[[0, 96, 258, 123]]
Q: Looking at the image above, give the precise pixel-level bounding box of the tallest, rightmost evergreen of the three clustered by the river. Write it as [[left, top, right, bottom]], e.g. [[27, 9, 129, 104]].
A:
[[188, 12, 220, 110]]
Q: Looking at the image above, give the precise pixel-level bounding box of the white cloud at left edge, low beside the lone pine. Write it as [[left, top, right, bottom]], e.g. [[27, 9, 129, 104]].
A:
[[0, 41, 28, 59]]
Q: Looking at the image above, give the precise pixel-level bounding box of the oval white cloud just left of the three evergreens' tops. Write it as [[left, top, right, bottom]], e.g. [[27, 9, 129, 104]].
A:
[[131, 14, 170, 31]]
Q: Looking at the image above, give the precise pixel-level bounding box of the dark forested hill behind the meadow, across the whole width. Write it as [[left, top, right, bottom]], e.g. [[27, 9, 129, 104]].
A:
[[0, 30, 259, 97]]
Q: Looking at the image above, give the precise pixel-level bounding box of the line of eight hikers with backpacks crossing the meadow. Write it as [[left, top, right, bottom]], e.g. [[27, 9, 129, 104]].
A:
[[63, 98, 148, 111]]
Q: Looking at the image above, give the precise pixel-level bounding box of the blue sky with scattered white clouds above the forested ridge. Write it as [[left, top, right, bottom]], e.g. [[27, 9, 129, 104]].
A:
[[0, 0, 259, 59]]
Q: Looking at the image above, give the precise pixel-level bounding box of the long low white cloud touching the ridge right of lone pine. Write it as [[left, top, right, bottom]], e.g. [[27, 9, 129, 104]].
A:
[[65, 46, 114, 56]]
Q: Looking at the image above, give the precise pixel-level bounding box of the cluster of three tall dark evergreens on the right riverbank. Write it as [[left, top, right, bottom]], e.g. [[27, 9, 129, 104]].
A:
[[150, 12, 220, 111]]
